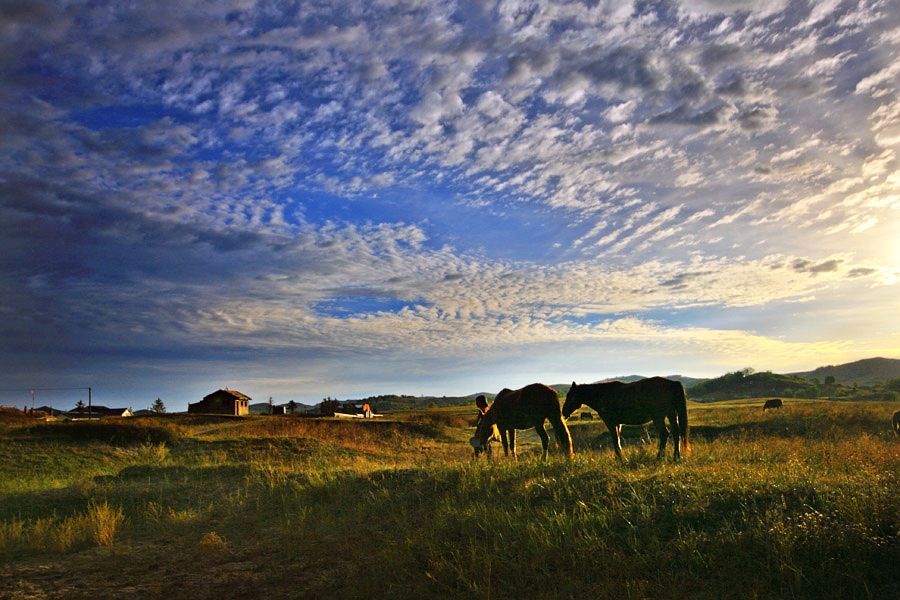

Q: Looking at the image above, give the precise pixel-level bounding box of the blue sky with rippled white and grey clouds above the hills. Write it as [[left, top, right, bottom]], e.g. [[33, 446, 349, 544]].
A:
[[0, 0, 900, 412]]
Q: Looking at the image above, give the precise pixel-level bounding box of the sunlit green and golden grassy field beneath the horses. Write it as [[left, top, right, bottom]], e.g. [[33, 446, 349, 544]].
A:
[[0, 400, 900, 599]]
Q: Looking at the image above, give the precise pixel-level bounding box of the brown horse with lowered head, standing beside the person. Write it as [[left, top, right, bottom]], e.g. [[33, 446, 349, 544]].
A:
[[470, 383, 572, 459]]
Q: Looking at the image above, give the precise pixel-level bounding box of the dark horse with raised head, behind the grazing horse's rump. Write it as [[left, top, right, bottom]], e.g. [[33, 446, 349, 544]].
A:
[[563, 377, 690, 460]]
